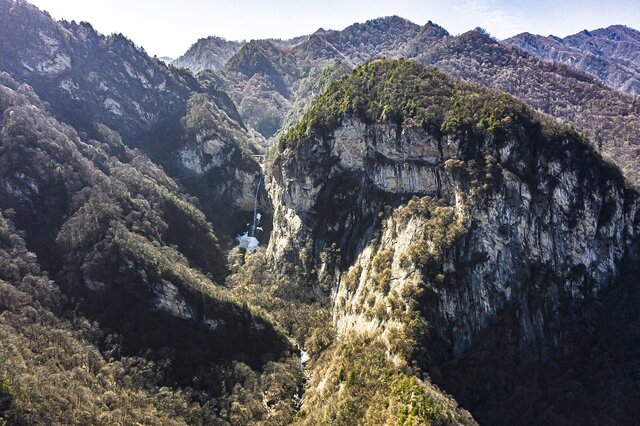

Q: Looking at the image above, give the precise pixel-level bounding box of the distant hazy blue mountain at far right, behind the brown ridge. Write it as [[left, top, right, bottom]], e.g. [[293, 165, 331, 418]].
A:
[[505, 25, 640, 95]]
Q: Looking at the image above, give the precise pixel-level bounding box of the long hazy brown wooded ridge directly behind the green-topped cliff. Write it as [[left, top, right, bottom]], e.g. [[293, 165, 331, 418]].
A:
[[182, 17, 640, 186]]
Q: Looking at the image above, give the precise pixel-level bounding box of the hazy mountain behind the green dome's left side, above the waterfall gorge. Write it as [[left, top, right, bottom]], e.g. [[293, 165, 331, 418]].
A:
[[221, 16, 421, 138]]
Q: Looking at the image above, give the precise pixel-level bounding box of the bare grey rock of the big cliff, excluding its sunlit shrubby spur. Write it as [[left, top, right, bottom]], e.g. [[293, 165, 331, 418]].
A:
[[269, 115, 638, 350]]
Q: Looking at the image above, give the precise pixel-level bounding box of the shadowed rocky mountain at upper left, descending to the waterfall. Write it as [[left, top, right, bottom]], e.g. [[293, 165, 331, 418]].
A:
[[0, 0, 264, 233]]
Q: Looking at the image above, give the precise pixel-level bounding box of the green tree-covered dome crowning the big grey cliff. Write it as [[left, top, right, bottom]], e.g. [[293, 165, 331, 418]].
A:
[[279, 59, 571, 150]]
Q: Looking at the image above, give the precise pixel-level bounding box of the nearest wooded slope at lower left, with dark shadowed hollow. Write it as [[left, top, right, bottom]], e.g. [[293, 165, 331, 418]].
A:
[[0, 73, 300, 425]]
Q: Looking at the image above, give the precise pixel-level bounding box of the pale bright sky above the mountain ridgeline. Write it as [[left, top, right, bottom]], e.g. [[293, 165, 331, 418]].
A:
[[30, 0, 640, 57]]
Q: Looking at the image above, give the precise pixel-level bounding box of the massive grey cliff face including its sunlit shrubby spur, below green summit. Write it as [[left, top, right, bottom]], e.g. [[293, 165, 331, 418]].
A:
[[268, 59, 640, 423]]
